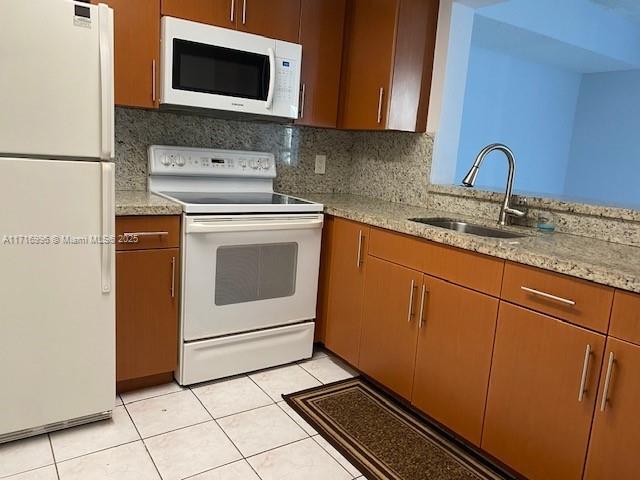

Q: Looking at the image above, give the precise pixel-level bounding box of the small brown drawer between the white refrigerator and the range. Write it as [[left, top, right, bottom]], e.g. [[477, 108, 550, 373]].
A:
[[116, 215, 180, 250]]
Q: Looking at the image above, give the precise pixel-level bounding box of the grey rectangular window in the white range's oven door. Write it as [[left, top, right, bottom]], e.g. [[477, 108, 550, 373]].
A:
[[214, 243, 298, 306]]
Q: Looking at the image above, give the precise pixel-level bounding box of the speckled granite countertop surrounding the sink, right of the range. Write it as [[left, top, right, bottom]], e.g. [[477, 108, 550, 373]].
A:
[[296, 193, 640, 293]]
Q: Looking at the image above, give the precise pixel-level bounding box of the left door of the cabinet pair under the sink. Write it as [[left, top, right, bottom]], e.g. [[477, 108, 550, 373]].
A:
[[359, 257, 422, 399]]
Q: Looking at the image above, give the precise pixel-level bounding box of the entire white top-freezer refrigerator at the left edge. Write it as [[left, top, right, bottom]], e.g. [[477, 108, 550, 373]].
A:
[[0, 0, 115, 443]]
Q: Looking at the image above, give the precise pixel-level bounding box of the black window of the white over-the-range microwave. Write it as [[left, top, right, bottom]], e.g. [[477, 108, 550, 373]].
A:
[[172, 39, 269, 101]]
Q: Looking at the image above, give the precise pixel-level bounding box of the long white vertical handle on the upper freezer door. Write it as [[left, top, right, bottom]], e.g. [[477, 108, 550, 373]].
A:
[[98, 3, 115, 160]]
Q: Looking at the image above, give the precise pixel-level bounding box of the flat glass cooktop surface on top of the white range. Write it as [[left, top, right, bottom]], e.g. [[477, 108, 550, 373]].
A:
[[162, 192, 312, 205]]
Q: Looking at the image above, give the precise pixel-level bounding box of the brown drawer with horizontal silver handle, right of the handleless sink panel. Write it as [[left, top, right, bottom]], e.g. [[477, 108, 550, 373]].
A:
[[502, 262, 614, 333]]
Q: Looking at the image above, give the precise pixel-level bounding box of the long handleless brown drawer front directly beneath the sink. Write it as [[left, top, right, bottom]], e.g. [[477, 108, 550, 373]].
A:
[[369, 228, 504, 297]]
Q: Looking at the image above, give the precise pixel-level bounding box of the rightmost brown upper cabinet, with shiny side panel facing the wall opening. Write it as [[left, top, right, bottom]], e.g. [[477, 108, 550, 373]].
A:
[[339, 0, 439, 132]]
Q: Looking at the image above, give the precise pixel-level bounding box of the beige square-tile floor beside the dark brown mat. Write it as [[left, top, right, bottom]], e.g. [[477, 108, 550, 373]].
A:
[[0, 351, 363, 480]]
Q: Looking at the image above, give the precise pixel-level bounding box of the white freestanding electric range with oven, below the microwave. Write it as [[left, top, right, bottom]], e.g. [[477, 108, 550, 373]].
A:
[[149, 146, 323, 385]]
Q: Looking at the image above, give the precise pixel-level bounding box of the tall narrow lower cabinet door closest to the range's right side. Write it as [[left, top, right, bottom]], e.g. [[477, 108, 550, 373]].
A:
[[325, 218, 369, 366]]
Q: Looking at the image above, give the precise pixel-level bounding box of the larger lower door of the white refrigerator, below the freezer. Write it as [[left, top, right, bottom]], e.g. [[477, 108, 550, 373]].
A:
[[0, 158, 115, 441]]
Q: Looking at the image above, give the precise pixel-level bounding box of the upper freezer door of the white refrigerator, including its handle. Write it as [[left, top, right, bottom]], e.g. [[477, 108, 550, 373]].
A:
[[0, 0, 113, 159]]
